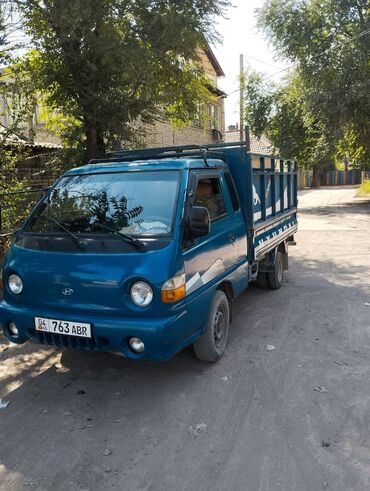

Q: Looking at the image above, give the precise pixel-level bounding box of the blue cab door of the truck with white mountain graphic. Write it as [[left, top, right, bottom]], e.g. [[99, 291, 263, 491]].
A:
[[184, 169, 238, 302]]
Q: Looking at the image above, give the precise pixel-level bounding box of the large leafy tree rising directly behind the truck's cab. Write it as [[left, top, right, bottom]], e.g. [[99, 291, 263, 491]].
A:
[[17, 0, 229, 159]]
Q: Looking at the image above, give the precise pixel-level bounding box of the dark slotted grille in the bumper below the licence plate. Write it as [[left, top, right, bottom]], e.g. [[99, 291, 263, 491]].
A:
[[28, 329, 109, 351]]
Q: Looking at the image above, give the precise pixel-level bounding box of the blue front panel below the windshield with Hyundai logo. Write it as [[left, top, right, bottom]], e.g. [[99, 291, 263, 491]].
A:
[[3, 242, 180, 317]]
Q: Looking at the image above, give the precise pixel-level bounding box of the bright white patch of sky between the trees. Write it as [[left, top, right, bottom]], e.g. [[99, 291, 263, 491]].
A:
[[212, 0, 289, 127]]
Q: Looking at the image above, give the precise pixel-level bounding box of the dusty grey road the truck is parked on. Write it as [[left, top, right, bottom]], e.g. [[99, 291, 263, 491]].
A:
[[0, 188, 370, 491]]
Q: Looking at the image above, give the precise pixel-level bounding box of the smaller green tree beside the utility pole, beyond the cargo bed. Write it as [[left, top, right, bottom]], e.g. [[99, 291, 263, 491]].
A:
[[245, 68, 336, 186]]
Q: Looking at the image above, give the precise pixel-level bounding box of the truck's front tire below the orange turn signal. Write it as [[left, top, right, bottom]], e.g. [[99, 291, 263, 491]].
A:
[[194, 290, 230, 363]]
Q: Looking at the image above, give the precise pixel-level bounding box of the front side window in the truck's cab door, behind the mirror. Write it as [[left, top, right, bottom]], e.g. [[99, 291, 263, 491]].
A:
[[194, 177, 226, 220]]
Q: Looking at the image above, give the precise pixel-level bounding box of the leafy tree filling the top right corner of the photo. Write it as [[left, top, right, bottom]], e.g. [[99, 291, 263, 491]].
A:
[[258, 0, 370, 163]]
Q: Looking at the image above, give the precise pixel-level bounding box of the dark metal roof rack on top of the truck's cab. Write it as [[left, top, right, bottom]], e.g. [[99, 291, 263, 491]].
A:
[[89, 142, 246, 167]]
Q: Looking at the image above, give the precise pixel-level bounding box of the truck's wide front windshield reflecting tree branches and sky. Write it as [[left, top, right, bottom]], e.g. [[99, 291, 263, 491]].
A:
[[24, 171, 179, 236]]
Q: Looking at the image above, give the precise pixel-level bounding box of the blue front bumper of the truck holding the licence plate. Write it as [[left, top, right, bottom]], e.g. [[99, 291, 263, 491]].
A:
[[0, 300, 192, 361]]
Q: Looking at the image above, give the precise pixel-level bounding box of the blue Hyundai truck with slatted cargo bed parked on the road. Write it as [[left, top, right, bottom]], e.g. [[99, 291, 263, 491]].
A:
[[0, 143, 298, 362]]
